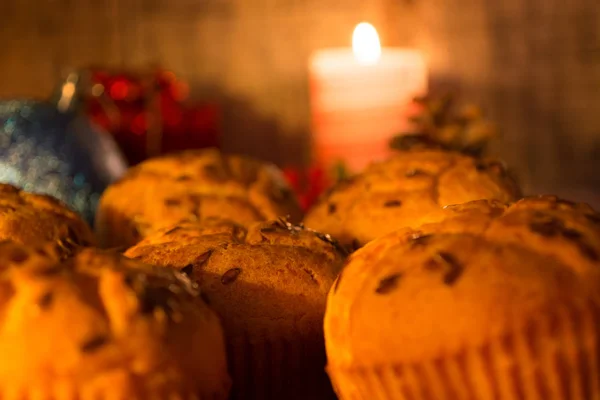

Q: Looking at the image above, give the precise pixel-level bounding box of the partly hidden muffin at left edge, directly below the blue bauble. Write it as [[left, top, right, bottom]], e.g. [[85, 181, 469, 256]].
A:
[[0, 183, 95, 258]]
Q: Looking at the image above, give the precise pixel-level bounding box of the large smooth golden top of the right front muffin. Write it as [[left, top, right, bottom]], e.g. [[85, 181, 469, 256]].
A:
[[325, 196, 600, 367]]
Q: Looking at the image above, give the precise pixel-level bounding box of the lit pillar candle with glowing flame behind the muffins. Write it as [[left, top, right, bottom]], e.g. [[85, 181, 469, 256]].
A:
[[309, 23, 427, 171]]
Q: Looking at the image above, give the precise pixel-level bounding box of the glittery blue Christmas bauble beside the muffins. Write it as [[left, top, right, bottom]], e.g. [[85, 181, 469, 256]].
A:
[[0, 100, 126, 223]]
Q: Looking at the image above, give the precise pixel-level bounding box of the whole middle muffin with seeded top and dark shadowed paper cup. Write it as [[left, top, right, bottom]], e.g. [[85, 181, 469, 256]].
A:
[[125, 219, 345, 399]]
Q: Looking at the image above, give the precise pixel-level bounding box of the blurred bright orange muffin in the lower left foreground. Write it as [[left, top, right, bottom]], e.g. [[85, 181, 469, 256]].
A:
[[0, 242, 230, 400]]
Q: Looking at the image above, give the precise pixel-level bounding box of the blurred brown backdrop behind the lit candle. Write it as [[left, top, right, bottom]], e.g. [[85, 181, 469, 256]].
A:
[[0, 0, 600, 207]]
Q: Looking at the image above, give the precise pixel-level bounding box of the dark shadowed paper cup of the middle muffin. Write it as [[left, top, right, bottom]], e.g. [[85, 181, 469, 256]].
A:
[[228, 332, 335, 400]]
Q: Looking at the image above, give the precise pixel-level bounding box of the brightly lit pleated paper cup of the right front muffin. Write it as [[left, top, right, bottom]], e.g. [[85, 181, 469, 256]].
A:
[[327, 302, 600, 400]]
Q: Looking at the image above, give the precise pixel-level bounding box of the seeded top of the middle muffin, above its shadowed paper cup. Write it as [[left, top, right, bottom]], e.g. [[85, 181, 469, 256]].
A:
[[125, 219, 345, 334]]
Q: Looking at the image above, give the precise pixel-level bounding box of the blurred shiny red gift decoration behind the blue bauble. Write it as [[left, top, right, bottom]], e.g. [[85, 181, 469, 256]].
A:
[[85, 69, 221, 165]]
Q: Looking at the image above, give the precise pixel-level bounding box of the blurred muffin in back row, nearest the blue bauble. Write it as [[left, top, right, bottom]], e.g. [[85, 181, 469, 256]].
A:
[[96, 149, 302, 247]]
